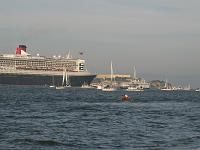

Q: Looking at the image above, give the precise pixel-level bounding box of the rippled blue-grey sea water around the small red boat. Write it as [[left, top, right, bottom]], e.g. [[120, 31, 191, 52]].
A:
[[0, 86, 200, 150]]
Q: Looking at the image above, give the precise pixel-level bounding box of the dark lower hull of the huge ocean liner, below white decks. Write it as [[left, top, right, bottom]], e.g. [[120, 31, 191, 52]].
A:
[[0, 74, 96, 86]]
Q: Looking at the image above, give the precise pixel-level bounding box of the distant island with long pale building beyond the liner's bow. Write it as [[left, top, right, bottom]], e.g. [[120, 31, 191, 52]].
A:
[[92, 71, 194, 91]]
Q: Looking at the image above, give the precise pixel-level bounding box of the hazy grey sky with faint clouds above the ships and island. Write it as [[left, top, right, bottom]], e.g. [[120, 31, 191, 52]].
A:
[[0, 0, 200, 88]]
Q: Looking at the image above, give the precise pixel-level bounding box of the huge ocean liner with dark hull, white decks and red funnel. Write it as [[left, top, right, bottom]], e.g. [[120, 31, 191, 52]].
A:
[[0, 45, 96, 86]]
